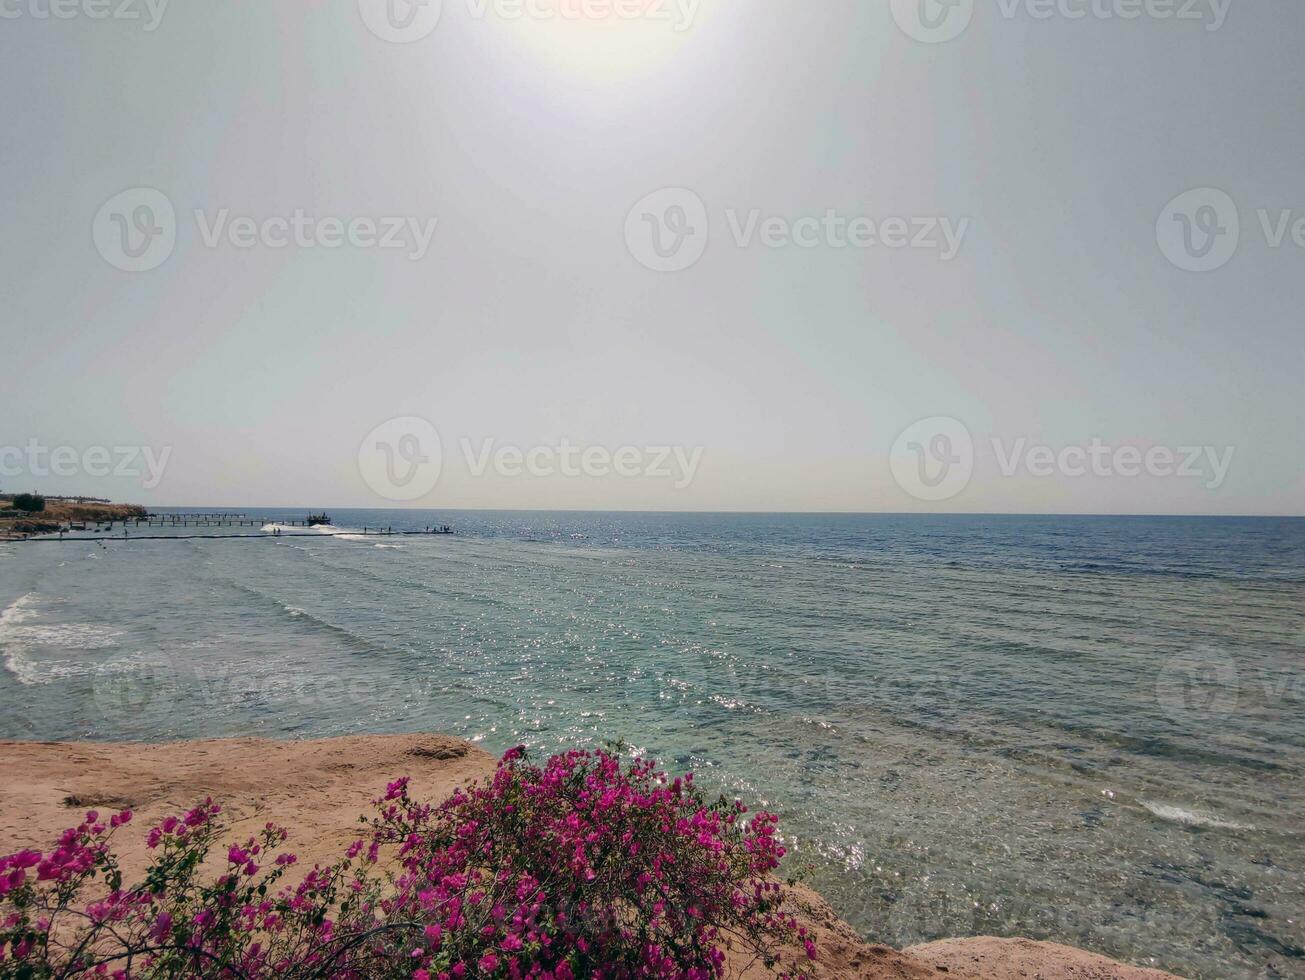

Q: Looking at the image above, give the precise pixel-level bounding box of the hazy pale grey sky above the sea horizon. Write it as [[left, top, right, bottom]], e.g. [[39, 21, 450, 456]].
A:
[[0, 0, 1305, 515]]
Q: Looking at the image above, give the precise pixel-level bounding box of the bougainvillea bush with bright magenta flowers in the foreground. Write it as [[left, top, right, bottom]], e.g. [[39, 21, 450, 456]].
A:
[[0, 748, 814, 980]]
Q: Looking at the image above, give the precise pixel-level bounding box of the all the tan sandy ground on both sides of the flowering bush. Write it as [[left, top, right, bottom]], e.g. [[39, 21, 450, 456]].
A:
[[0, 735, 1171, 980]]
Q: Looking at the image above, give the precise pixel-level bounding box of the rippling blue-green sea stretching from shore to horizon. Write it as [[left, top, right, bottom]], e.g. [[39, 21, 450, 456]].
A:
[[0, 510, 1305, 977]]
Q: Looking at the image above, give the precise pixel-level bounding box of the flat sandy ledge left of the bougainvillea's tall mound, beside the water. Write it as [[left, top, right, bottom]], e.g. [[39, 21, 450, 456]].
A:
[[0, 735, 493, 877]]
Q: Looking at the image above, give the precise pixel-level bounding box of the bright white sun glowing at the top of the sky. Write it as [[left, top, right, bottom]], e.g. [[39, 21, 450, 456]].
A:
[[485, 0, 716, 78]]
